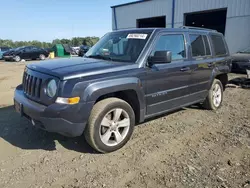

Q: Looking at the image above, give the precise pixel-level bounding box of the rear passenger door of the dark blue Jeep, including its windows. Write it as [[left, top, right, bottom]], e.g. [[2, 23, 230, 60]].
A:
[[189, 32, 216, 101]]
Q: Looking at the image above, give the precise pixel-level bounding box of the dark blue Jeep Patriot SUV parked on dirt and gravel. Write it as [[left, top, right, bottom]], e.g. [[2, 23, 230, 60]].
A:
[[14, 27, 231, 153]]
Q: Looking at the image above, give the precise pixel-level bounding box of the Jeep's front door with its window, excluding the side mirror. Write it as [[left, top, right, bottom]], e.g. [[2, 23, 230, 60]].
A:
[[146, 32, 192, 117]]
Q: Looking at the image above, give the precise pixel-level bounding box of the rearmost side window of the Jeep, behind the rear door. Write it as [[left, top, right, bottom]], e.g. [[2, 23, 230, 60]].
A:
[[211, 35, 227, 56]]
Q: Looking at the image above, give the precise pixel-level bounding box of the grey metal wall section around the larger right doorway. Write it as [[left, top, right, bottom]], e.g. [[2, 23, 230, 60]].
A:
[[174, 0, 250, 53]]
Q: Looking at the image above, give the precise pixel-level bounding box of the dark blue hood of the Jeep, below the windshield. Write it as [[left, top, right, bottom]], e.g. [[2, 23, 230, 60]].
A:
[[27, 58, 137, 80]]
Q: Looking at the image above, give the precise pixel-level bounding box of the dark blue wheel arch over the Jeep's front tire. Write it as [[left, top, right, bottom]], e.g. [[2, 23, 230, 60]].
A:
[[82, 77, 146, 123]]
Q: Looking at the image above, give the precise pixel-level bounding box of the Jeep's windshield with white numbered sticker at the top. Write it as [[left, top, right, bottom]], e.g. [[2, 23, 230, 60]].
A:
[[84, 30, 152, 63]]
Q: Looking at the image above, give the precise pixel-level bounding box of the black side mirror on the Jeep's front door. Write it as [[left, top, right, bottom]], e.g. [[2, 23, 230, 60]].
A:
[[148, 51, 172, 65]]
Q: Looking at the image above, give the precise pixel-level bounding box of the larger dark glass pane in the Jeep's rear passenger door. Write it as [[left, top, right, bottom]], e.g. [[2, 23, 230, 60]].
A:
[[190, 34, 206, 57]]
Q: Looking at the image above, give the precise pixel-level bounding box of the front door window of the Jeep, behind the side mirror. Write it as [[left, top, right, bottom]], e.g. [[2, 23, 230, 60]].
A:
[[151, 34, 186, 60]]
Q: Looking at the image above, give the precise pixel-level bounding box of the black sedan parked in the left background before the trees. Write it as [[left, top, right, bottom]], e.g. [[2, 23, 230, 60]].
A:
[[3, 46, 49, 62]]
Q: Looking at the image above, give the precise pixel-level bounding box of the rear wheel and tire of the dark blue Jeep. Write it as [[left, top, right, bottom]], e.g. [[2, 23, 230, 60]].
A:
[[202, 79, 223, 111]]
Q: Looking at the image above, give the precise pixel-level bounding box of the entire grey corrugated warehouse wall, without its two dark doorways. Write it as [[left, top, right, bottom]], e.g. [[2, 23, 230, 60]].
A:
[[112, 0, 250, 53]]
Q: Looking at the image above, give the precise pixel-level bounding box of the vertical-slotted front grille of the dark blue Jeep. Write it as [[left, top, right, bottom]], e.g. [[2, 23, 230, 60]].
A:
[[23, 72, 43, 99]]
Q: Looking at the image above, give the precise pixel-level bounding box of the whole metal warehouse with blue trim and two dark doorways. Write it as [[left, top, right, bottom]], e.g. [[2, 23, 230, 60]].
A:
[[111, 0, 250, 53]]
